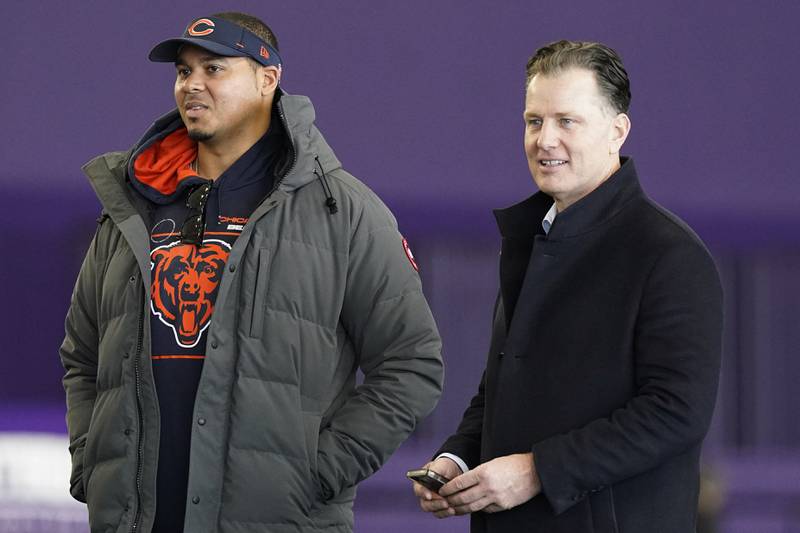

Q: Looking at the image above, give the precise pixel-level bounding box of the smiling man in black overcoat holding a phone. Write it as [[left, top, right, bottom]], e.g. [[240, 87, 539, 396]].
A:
[[414, 41, 722, 533]]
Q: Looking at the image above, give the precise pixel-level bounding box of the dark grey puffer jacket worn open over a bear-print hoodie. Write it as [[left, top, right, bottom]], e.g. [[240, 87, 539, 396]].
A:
[[60, 94, 443, 533]]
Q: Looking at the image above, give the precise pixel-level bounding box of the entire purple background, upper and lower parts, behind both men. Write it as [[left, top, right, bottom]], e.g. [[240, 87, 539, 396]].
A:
[[0, 0, 800, 533]]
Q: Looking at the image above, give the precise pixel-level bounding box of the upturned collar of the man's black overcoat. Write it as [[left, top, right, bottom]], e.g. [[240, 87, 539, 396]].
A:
[[494, 157, 643, 240]]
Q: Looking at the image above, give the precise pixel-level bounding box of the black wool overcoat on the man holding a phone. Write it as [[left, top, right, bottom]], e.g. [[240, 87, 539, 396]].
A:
[[440, 159, 722, 533]]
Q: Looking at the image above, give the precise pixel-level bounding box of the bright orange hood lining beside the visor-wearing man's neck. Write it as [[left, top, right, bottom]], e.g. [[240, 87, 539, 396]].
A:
[[133, 128, 197, 196]]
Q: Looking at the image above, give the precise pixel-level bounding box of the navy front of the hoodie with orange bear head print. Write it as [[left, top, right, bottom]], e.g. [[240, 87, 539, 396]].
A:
[[150, 127, 280, 533]]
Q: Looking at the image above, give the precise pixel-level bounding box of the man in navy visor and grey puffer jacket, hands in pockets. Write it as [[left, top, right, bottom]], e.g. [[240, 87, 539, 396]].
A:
[[60, 13, 442, 533]]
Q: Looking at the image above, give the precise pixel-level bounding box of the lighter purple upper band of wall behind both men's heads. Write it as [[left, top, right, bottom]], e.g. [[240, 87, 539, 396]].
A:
[[0, 0, 800, 216]]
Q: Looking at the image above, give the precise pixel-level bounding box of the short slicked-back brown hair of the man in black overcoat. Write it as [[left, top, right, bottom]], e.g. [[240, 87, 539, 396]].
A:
[[525, 40, 631, 113]]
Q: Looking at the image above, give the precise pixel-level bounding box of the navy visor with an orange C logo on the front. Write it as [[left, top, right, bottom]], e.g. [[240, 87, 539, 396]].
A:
[[149, 17, 281, 68]]
